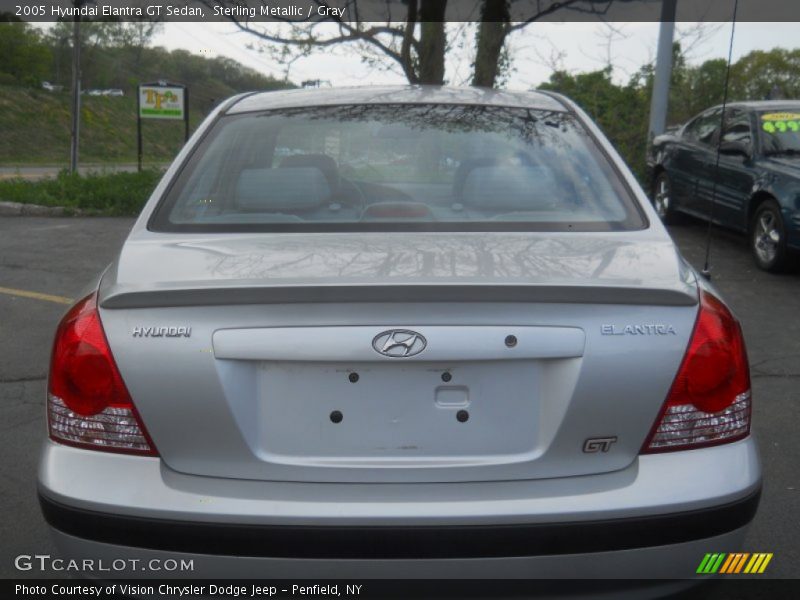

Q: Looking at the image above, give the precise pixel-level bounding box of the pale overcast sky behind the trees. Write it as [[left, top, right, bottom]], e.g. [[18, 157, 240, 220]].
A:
[[154, 22, 798, 89]]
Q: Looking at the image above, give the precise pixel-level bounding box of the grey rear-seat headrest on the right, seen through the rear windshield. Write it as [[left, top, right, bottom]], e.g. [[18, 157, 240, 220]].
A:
[[460, 166, 558, 211]]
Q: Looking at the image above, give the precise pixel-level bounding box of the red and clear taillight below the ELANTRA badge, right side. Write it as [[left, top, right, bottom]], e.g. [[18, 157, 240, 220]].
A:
[[642, 290, 751, 454]]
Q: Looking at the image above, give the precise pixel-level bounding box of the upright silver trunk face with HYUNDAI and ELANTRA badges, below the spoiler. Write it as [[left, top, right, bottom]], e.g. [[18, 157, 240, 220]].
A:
[[95, 302, 697, 482]]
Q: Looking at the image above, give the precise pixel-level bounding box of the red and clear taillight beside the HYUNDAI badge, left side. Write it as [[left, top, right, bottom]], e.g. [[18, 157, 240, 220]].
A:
[[47, 293, 157, 456]]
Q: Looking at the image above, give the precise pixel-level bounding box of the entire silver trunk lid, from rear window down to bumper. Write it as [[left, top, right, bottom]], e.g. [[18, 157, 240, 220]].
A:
[[101, 234, 697, 482]]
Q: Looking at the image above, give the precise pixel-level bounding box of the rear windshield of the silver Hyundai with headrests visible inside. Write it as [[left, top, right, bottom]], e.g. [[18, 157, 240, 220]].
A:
[[150, 104, 643, 232]]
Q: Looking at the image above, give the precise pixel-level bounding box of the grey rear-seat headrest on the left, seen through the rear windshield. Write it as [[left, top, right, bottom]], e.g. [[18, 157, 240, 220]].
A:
[[236, 167, 331, 212]]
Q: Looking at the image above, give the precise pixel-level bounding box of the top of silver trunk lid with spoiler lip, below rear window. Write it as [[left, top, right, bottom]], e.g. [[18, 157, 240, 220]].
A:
[[100, 231, 697, 308]]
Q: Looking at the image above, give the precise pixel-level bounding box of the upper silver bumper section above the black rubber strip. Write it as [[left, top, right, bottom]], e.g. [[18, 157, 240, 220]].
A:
[[39, 438, 761, 526]]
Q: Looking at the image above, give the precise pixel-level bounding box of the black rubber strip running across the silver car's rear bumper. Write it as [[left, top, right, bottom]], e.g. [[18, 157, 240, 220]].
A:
[[39, 492, 760, 560]]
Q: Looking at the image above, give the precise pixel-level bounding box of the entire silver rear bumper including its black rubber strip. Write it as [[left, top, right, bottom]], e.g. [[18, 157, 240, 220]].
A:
[[39, 438, 761, 578]]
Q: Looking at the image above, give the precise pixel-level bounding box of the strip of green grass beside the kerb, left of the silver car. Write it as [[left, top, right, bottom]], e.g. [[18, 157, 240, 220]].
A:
[[0, 169, 162, 217]]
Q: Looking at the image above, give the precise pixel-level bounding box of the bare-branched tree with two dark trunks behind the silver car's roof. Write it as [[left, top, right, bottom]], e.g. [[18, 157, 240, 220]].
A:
[[201, 0, 620, 87]]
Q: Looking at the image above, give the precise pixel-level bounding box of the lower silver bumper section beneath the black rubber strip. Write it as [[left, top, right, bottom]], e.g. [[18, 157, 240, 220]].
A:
[[52, 528, 746, 584]]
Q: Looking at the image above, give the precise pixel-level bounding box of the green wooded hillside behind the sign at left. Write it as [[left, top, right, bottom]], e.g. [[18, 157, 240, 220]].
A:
[[0, 20, 294, 166]]
